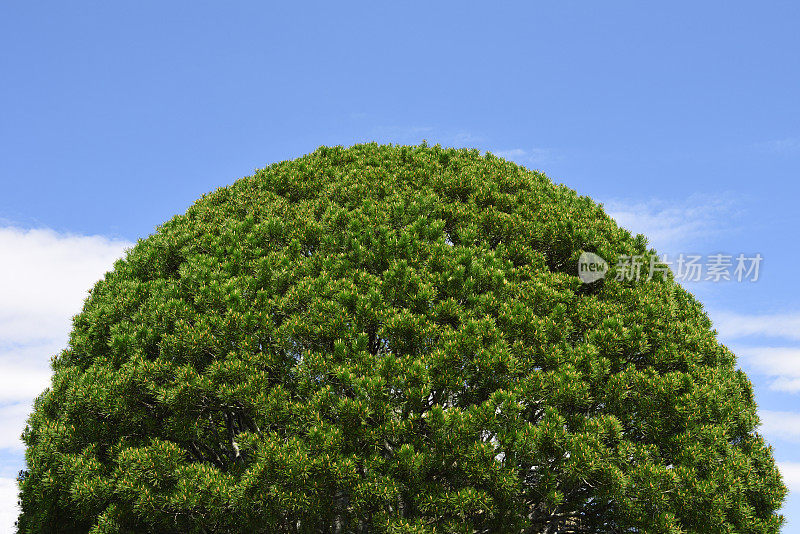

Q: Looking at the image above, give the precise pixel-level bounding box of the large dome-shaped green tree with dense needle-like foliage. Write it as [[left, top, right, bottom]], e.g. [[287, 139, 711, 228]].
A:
[[18, 144, 786, 534]]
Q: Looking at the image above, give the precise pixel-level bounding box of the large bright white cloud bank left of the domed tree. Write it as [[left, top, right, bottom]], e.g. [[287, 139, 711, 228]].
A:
[[0, 226, 132, 449]]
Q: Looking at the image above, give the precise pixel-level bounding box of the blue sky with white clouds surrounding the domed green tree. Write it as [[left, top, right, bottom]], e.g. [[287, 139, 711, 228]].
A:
[[0, 1, 800, 533]]
